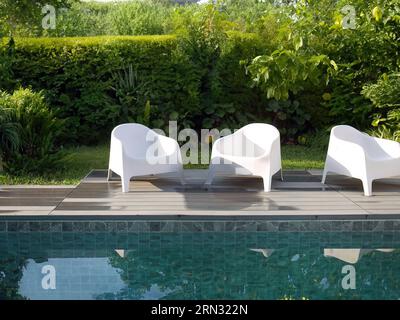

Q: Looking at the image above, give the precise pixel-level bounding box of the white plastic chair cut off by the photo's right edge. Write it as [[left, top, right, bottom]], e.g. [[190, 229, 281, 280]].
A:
[[322, 125, 400, 196]]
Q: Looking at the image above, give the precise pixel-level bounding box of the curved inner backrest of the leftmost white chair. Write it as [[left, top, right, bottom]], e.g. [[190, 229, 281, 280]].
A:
[[112, 123, 158, 158]]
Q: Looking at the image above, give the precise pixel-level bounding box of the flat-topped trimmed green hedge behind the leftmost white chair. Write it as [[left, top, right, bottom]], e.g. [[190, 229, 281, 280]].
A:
[[9, 36, 202, 143]]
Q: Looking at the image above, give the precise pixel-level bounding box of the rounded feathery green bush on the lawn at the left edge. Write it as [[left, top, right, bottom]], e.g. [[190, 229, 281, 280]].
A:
[[0, 89, 63, 173]]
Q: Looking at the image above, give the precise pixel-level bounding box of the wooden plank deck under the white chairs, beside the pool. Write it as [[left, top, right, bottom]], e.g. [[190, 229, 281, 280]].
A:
[[0, 170, 400, 219]]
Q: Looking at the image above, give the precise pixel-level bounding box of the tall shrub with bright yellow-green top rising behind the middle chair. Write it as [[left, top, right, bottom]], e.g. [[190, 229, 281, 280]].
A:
[[172, 4, 266, 129]]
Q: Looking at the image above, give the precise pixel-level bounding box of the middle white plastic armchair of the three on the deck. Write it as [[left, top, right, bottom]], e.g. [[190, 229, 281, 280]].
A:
[[205, 123, 283, 192]]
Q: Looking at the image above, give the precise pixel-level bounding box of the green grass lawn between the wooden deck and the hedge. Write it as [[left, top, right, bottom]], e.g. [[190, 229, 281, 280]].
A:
[[0, 145, 325, 185]]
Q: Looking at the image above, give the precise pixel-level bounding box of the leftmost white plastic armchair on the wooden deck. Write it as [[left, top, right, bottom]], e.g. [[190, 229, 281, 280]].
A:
[[108, 123, 185, 193]]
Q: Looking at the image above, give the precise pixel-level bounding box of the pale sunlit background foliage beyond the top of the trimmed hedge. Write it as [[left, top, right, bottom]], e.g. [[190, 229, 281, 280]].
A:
[[0, 0, 273, 37]]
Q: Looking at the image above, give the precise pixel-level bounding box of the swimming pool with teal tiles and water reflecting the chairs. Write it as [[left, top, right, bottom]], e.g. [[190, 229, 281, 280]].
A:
[[0, 220, 400, 300]]
